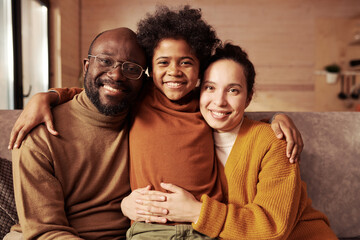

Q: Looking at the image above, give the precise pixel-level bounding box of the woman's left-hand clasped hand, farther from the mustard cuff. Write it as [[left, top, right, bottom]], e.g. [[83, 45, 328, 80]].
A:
[[121, 186, 168, 223]]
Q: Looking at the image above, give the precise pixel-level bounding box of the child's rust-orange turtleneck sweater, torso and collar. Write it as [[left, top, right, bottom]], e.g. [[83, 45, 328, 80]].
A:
[[129, 85, 222, 201]]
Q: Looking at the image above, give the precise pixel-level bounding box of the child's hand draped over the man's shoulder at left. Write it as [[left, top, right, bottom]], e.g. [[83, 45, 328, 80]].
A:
[[8, 92, 59, 149]]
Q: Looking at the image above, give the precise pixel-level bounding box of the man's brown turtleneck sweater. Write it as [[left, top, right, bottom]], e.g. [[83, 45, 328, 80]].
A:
[[13, 92, 130, 240]]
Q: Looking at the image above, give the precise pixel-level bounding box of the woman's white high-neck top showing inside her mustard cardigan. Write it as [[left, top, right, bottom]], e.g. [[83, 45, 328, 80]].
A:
[[213, 118, 244, 166]]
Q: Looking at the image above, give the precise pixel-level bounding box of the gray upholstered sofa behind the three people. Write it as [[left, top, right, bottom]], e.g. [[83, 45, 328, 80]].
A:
[[0, 110, 360, 239]]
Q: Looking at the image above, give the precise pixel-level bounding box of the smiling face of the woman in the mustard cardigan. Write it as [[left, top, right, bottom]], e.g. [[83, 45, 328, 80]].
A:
[[200, 59, 251, 132]]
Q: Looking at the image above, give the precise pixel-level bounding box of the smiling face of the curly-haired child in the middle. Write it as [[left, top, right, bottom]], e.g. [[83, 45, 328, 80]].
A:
[[150, 38, 200, 101]]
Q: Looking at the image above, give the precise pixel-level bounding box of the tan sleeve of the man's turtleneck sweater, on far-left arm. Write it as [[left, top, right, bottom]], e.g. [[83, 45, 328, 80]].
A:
[[12, 142, 81, 240]]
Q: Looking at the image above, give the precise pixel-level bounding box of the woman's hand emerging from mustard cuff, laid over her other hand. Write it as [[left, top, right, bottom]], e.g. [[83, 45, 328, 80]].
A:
[[137, 183, 202, 223]]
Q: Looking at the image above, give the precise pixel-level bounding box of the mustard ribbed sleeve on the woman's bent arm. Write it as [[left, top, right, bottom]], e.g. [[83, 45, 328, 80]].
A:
[[193, 141, 301, 240]]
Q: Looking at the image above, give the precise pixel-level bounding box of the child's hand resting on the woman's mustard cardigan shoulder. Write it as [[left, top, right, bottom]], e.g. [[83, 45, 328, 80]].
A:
[[271, 113, 304, 163]]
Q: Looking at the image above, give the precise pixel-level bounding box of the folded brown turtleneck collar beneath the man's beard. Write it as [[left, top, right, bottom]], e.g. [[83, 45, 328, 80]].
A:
[[73, 91, 128, 129]]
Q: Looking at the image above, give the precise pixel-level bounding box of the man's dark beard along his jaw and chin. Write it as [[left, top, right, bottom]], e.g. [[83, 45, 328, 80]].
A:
[[84, 72, 131, 116]]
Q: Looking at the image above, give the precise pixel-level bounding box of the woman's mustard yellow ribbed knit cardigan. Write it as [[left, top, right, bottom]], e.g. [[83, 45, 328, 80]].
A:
[[193, 118, 337, 240]]
